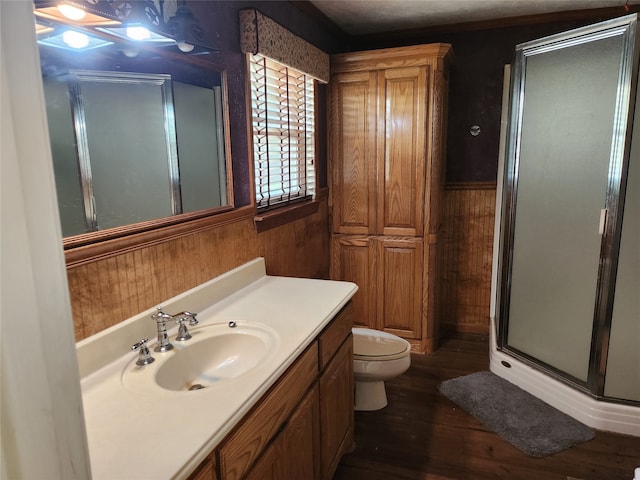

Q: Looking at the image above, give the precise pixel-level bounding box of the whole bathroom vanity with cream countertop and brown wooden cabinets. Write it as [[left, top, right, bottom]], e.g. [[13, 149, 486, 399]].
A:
[[78, 259, 357, 480]]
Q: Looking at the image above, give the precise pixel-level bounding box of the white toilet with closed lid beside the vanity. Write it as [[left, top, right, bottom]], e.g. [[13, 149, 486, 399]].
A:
[[352, 328, 411, 410]]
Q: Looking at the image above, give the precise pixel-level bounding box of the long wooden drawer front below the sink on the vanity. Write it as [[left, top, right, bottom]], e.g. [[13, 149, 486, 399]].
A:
[[219, 342, 318, 480]]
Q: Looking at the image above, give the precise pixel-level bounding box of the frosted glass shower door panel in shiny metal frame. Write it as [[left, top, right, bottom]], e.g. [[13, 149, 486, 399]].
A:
[[500, 14, 635, 388]]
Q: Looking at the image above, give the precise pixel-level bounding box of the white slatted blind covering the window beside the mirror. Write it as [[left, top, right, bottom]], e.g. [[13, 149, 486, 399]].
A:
[[249, 55, 315, 208]]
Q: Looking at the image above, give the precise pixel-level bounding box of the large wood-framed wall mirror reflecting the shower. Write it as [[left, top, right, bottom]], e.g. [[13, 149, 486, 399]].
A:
[[36, 1, 233, 253]]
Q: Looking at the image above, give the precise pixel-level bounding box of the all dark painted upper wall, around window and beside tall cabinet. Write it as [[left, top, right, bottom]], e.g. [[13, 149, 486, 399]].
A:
[[189, 0, 628, 188]]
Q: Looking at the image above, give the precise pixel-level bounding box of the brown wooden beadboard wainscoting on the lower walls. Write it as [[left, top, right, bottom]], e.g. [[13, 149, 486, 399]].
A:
[[67, 183, 495, 340]]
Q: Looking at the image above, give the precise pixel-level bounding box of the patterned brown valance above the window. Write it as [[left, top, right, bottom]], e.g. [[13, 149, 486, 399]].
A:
[[240, 9, 329, 83]]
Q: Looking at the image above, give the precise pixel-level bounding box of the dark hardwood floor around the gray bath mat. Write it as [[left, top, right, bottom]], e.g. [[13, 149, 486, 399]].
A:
[[334, 335, 640, 480]]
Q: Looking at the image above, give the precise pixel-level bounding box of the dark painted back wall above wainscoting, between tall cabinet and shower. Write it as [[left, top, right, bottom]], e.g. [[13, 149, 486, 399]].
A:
[[344, 14, 632, 182]]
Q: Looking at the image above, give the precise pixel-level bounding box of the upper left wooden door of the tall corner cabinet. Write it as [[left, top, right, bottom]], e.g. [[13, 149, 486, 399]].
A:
[[329, 72, 377, 235]]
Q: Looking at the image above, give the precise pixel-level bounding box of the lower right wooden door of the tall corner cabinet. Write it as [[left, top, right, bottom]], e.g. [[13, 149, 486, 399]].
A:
[[375, 237, 424, 340]]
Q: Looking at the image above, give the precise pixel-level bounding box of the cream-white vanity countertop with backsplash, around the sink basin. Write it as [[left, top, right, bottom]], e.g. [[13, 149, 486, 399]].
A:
[[78, 259, 357, 480]]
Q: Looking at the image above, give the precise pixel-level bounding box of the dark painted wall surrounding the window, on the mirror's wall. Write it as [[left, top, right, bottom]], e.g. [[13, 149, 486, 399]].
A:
[[189, 0, 344, 206]]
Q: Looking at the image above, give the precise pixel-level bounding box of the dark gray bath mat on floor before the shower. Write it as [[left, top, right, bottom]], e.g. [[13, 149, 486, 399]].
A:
[[438, 372, 595, 457]]
